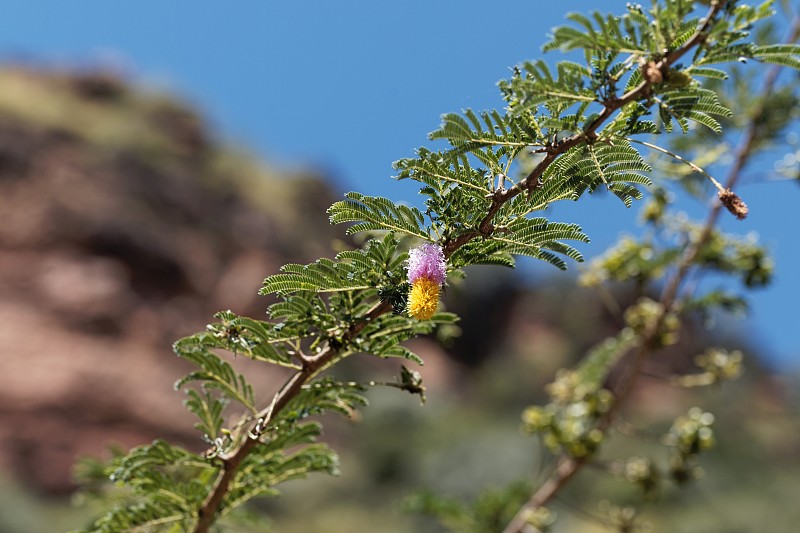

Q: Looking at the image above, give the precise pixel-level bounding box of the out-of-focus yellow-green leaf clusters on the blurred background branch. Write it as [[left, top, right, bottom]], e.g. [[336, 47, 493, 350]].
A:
[[522, 188, 769, 527]]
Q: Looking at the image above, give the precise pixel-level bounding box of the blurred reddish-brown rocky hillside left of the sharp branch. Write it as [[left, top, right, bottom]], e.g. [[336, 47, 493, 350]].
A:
[[0, 68, 337, 493]]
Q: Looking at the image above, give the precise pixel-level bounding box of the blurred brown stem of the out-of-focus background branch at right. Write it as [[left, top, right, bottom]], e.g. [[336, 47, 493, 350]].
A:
[[503, 11, 800, 533]]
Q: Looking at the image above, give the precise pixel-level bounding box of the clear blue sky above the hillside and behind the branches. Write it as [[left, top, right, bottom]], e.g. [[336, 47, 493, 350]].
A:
[[0, 0, 800, 366]]
